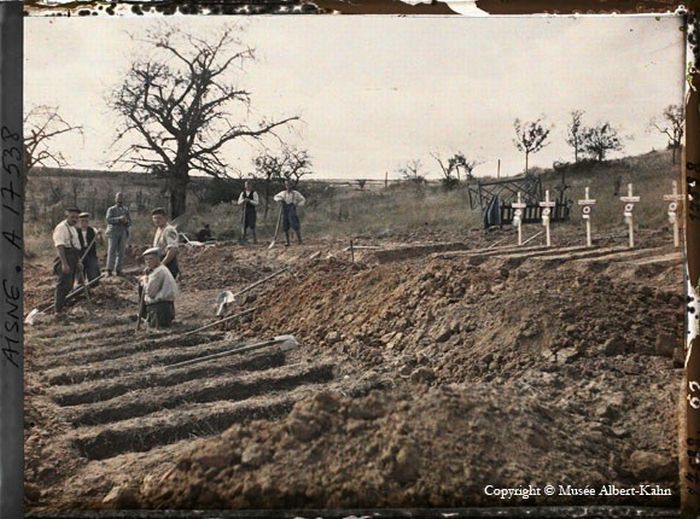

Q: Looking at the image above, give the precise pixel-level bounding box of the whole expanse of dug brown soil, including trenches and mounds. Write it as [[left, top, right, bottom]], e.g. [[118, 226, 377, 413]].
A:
[[25, 226, 685, 511]]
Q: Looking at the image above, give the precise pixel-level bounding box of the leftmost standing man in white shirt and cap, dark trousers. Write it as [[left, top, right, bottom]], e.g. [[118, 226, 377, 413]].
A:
[[53, 207, 82, 317]]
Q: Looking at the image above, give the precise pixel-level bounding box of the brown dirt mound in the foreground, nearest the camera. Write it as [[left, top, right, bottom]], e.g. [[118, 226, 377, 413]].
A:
[[140, 385, 676, 508]]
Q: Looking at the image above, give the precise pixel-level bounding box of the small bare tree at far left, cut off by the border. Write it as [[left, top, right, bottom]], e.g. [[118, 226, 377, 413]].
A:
[[24, 105, 83, 177]]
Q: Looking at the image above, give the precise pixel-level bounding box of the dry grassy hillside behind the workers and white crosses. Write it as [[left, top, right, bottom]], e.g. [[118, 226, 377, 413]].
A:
[[25, 147, 680, 258]]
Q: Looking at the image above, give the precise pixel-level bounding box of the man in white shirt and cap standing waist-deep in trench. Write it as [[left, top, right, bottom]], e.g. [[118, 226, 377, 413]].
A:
[[139, 247, 178, 328]]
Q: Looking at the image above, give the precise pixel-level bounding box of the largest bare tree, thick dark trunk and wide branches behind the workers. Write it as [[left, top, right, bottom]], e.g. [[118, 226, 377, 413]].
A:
[[108, 26, 298, 216]]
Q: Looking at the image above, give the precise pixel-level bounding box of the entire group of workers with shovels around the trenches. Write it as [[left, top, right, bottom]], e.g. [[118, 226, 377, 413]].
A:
[[53, 180, 305, 328]]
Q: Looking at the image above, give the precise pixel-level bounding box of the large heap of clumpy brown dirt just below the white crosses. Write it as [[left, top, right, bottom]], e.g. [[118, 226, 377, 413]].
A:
[[248, 254, 683, 382]]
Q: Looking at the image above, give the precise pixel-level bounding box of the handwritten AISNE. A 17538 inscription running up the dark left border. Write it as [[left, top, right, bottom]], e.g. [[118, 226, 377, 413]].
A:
[[0, 126, 23, 369]]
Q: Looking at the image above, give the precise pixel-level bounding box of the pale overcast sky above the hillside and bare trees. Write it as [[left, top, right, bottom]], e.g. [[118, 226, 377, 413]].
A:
[[24, 16, 684, 178]]
